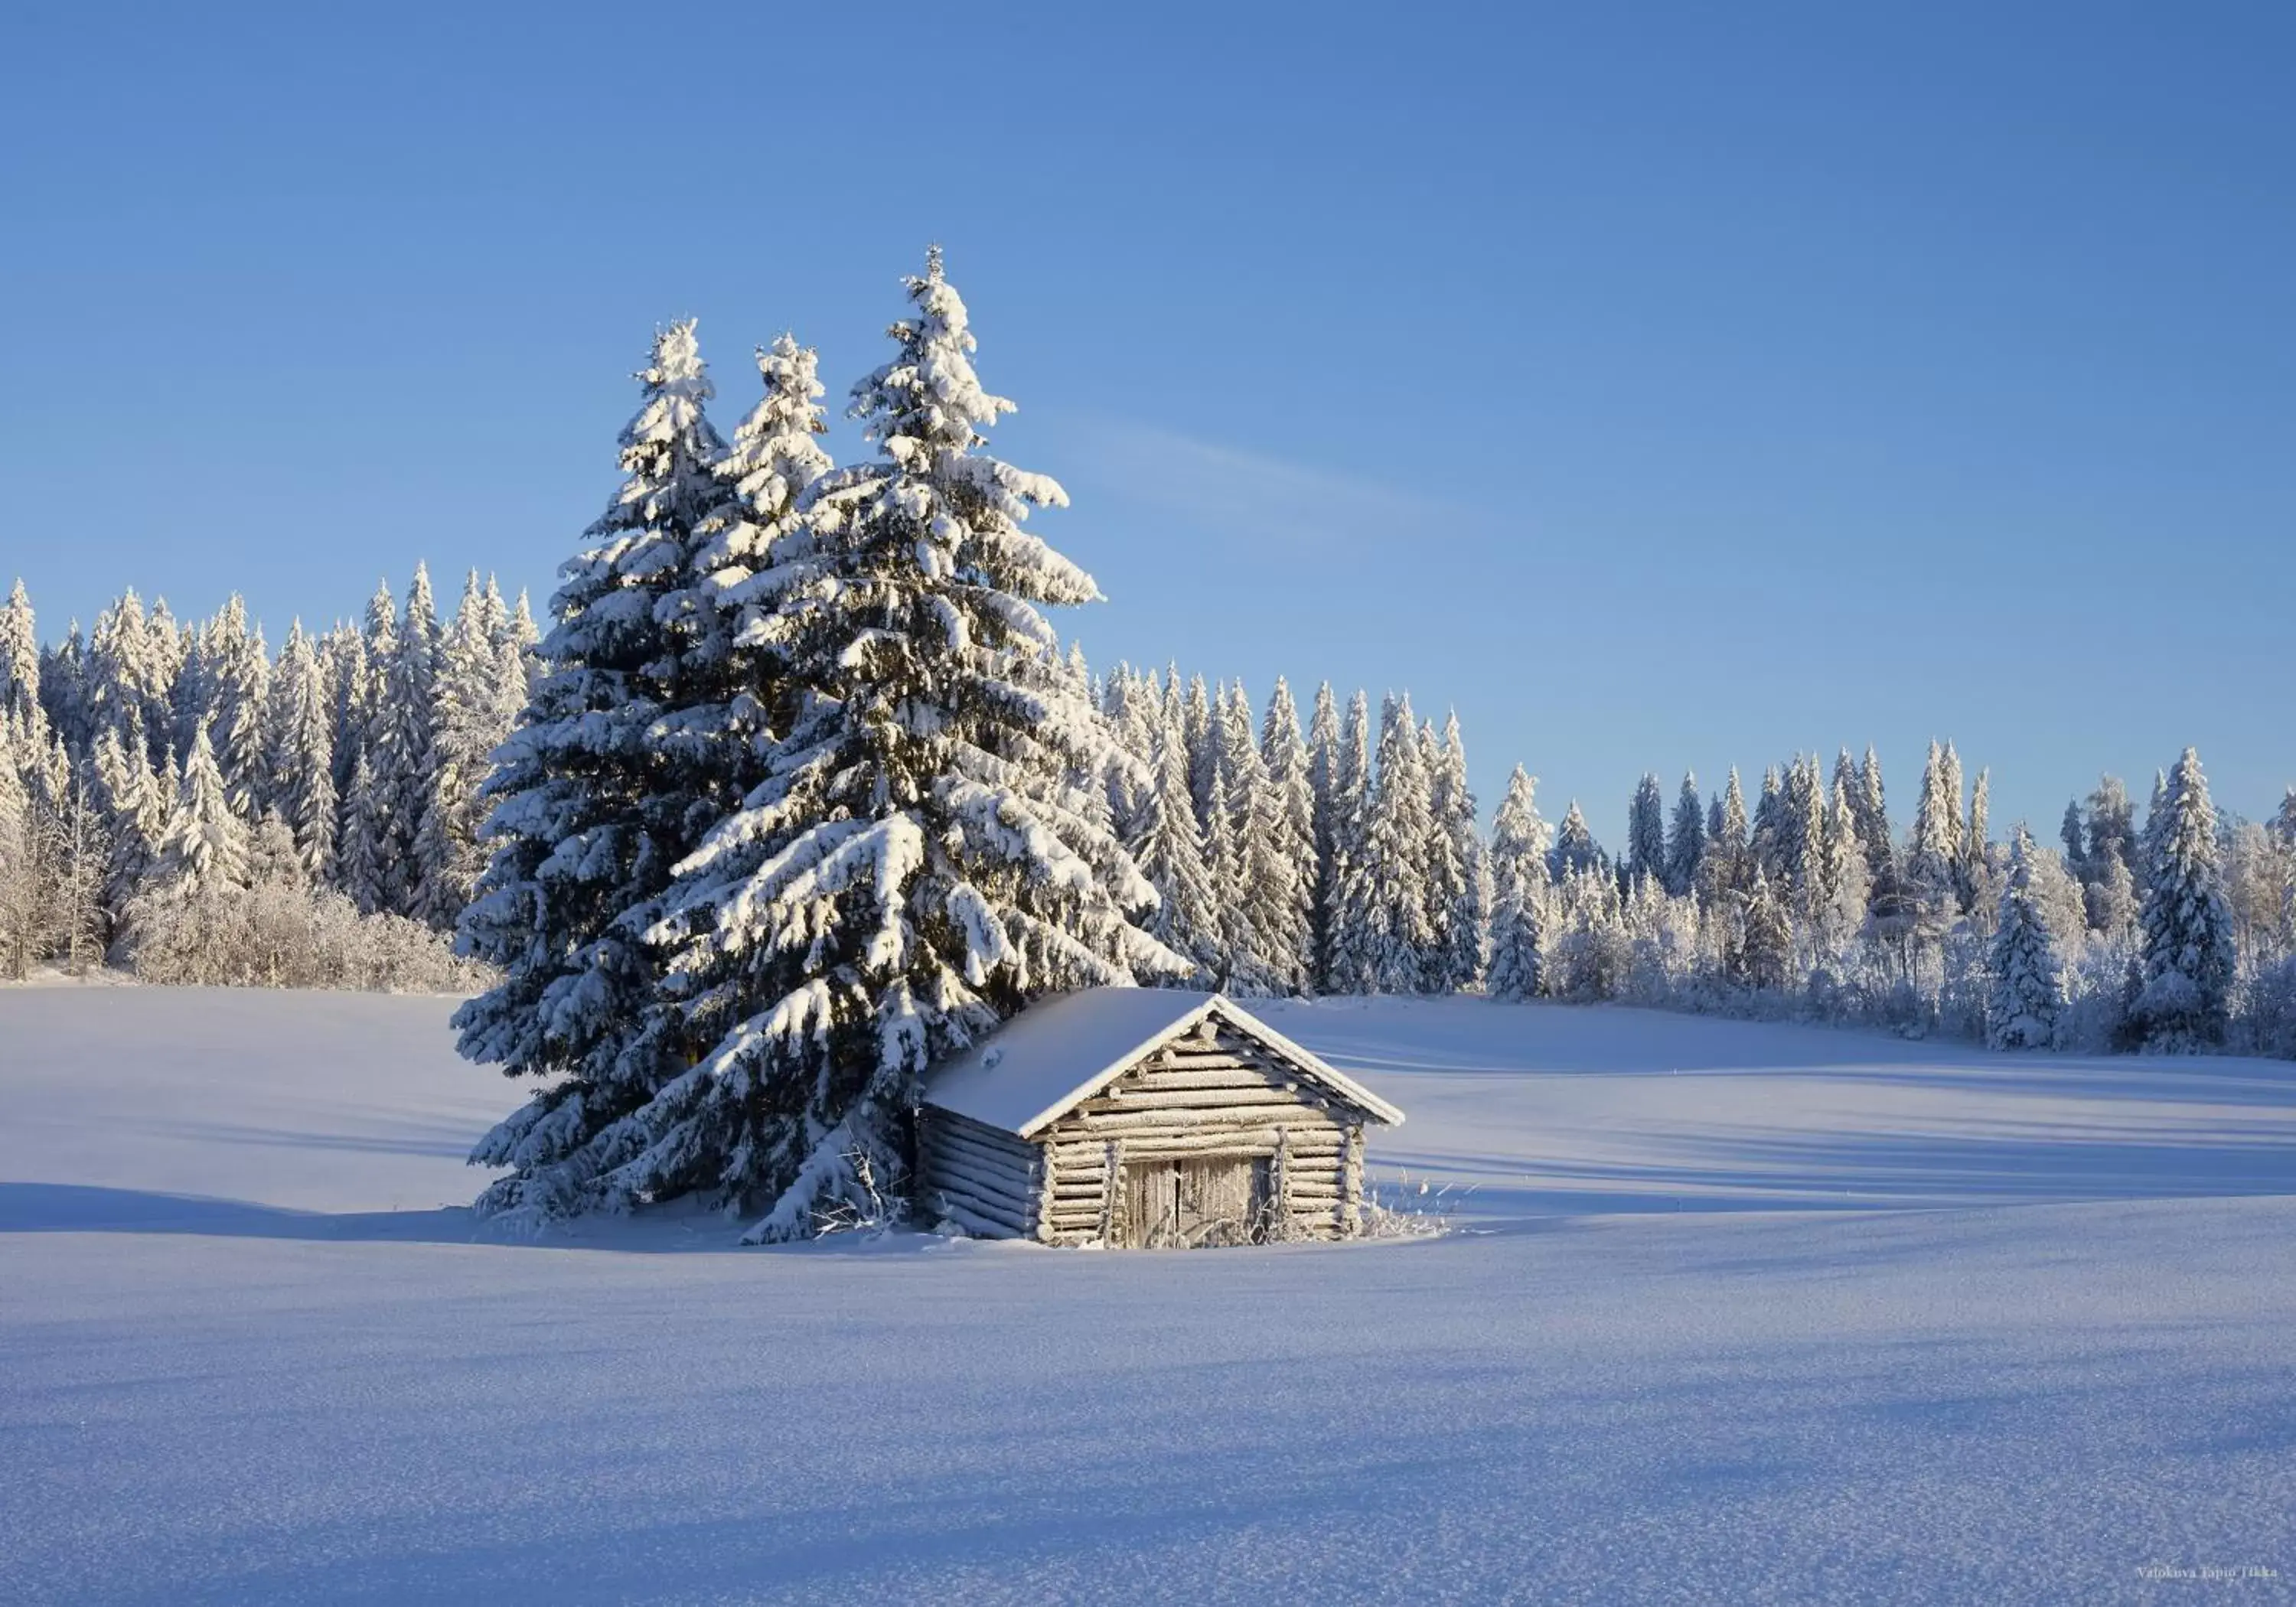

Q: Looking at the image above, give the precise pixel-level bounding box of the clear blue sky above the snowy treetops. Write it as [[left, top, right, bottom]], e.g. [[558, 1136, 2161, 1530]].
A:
[[0, 2, 2296, 843]]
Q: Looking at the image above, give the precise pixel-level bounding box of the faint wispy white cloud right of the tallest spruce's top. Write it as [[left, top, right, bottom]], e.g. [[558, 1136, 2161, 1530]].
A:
[[1047, 416, 1474, 549]]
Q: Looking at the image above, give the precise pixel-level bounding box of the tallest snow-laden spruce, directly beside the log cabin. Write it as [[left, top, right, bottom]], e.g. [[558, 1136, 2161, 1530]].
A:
[[629, 250, 1187, 1242]]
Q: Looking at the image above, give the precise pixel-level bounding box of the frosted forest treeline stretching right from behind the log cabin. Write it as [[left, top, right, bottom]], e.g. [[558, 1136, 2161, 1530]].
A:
[[1093, 666, 2296, 1054]]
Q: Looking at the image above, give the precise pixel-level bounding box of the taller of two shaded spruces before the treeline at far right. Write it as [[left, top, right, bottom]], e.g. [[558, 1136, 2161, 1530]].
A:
[[2131, 748, 2234, 1054]]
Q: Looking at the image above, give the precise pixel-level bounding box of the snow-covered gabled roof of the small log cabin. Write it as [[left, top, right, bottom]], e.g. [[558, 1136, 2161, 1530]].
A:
[[923, 987, 1403, 1139]]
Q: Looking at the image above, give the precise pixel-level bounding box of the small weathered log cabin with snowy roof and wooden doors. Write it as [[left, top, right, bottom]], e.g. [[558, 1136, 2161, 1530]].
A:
[[916, 987, 1403, 1249]]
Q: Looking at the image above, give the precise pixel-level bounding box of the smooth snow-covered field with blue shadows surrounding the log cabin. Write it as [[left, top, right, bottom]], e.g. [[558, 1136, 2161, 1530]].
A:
[[0, 987, 2296, 1602]]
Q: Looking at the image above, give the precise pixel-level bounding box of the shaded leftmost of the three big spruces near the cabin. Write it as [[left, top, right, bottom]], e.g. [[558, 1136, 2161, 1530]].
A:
[[455, 321, 748, 1217]]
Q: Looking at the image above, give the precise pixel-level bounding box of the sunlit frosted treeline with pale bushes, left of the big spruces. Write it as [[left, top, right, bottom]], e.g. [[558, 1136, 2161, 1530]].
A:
[[0, 567, 535, 987]]
